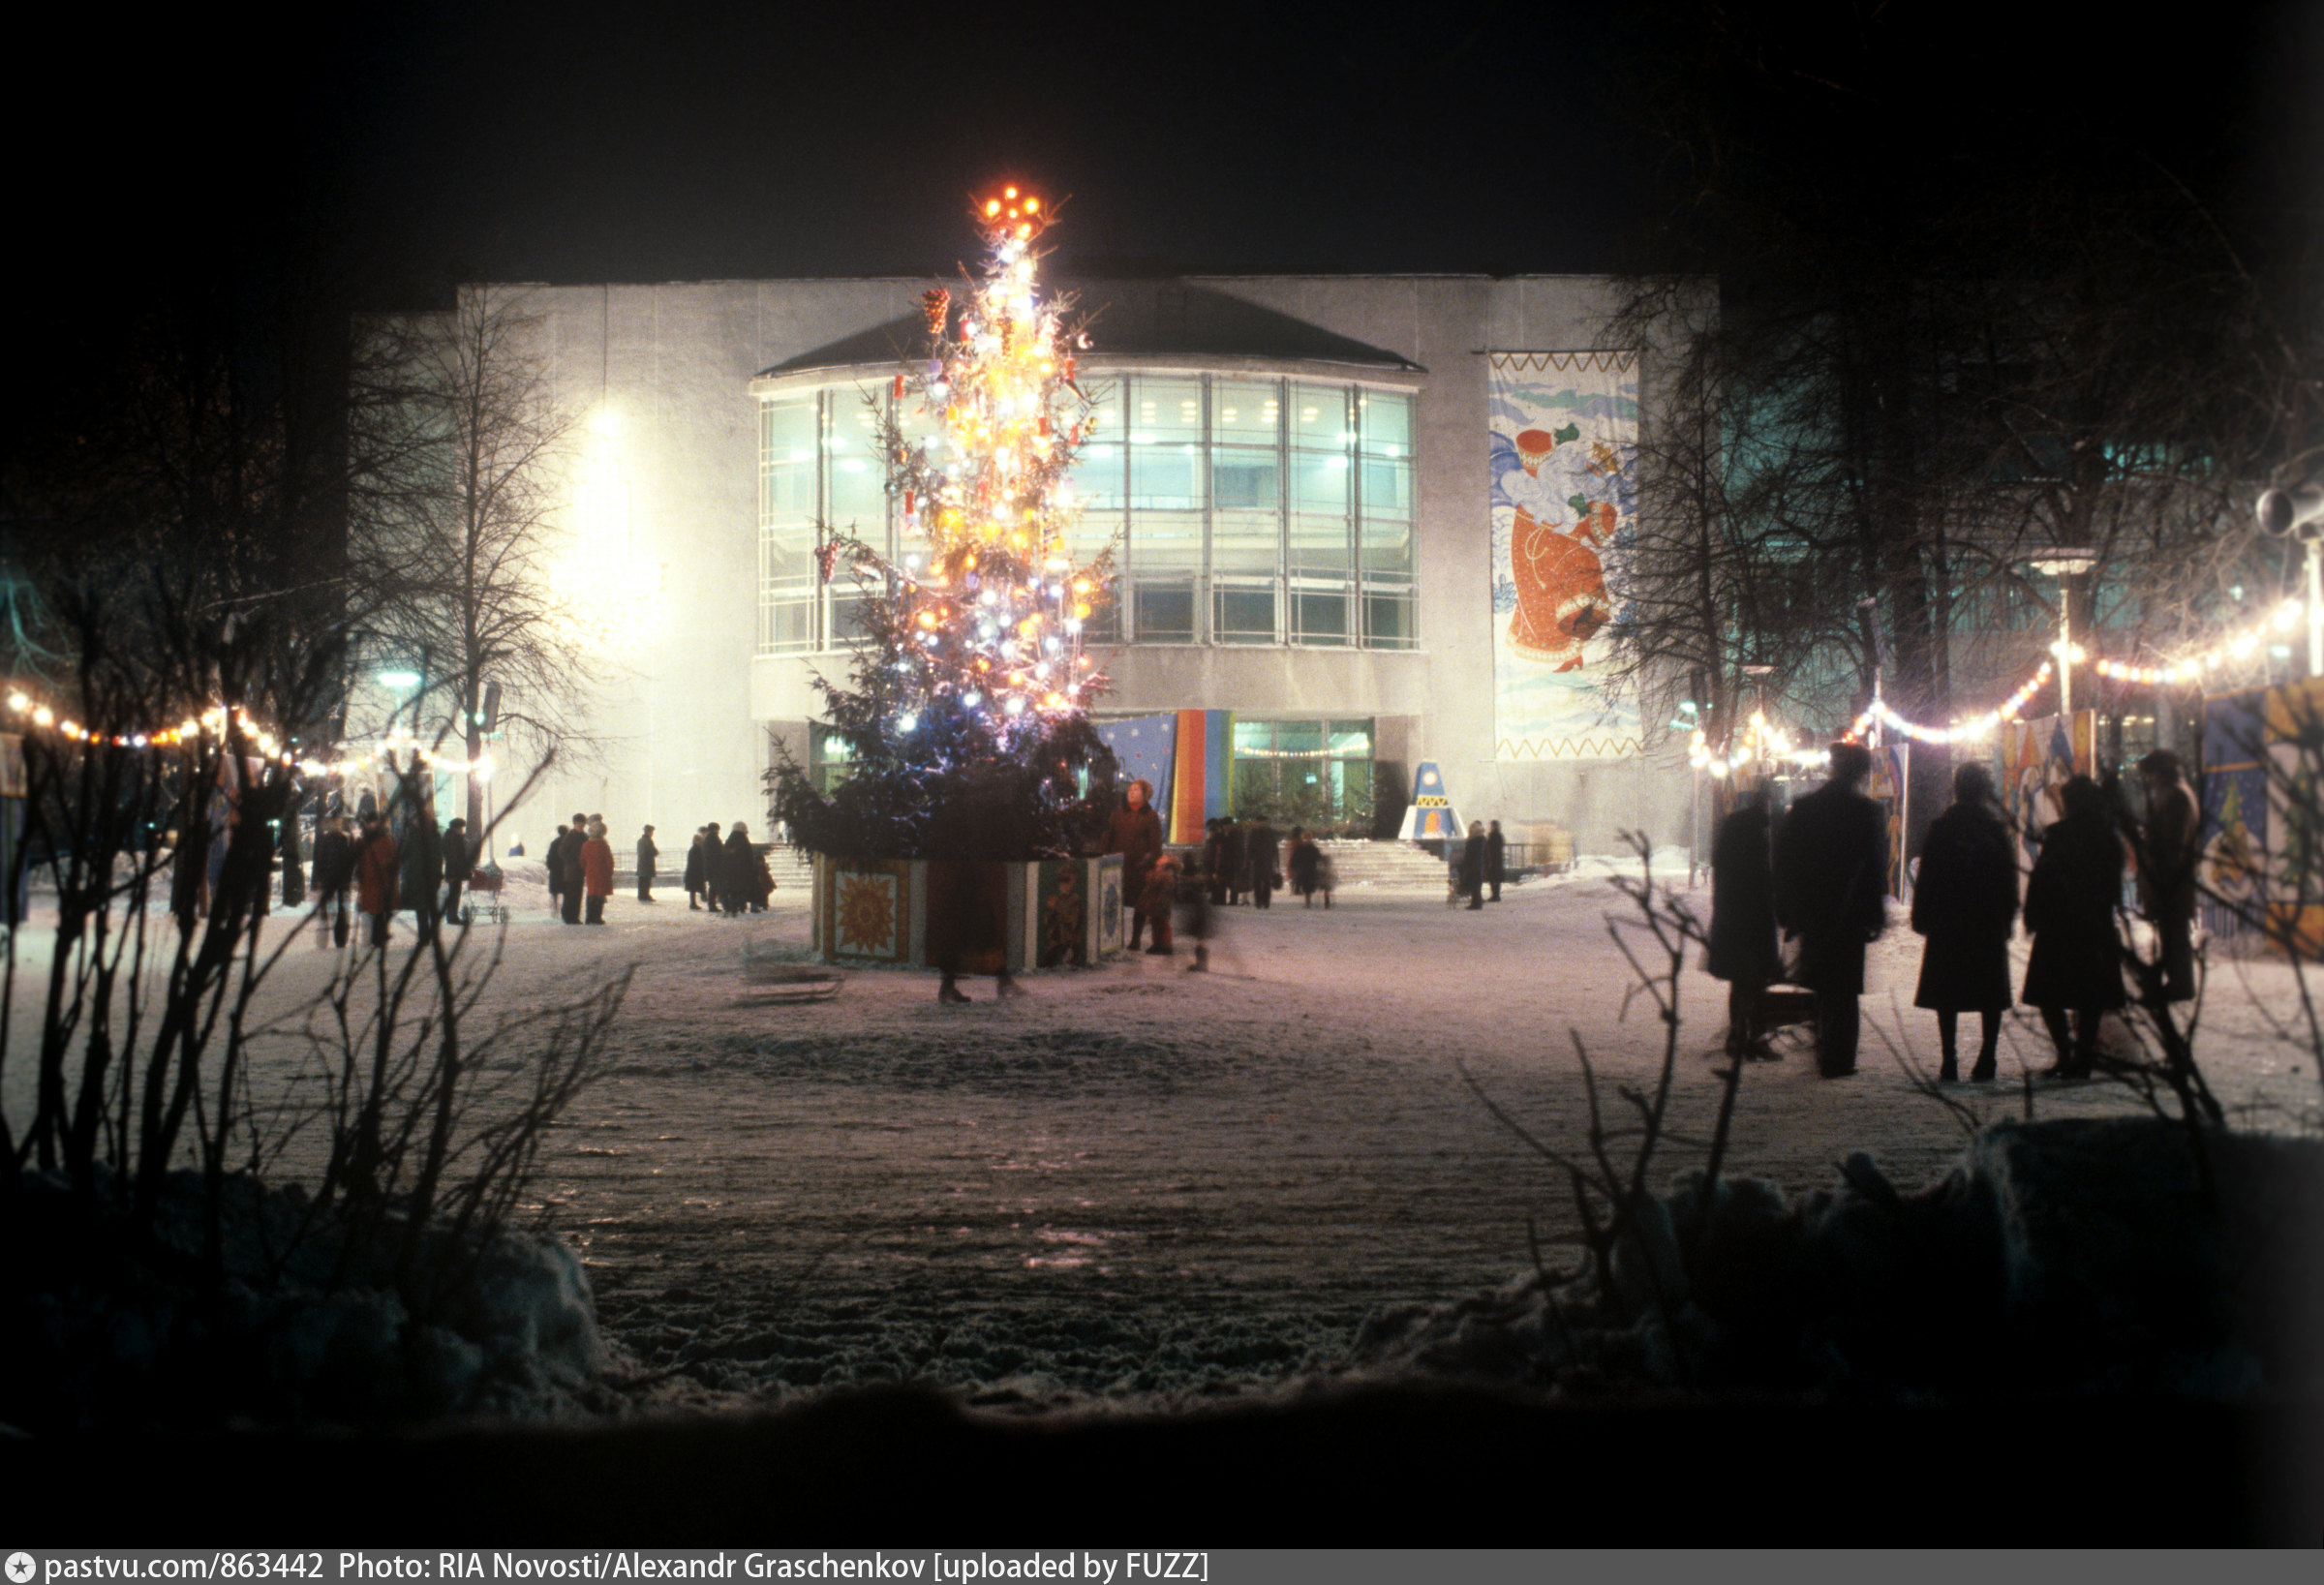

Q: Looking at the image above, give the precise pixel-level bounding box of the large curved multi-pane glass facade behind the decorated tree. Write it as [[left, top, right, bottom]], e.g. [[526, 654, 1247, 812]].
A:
[[757, 374, 1418, 651]]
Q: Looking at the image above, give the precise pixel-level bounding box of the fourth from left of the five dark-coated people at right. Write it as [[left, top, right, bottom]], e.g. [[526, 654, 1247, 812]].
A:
[[2024, 777, 2128, 1079]]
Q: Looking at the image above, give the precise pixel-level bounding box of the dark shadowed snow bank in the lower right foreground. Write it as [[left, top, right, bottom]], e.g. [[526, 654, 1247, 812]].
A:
[[1355, 1118, 2324, 1397]]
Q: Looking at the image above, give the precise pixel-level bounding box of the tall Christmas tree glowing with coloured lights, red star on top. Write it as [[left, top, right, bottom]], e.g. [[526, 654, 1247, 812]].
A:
[[767, 186, 1114, 860]]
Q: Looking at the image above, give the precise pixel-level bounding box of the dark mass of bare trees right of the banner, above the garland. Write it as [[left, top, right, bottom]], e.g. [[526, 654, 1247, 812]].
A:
[[1613, 5, 2319, 739]]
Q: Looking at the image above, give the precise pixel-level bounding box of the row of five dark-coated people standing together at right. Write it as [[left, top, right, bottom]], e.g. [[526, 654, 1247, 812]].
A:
[[1708, 744, 2201, 1083]]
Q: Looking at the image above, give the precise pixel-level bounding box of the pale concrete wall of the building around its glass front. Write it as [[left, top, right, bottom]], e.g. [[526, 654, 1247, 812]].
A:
[[480, 277, 1687, 851]]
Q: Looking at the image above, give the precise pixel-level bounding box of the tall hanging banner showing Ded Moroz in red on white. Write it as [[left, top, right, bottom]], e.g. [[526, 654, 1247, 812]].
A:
[[1487, 351, 1640, 760]]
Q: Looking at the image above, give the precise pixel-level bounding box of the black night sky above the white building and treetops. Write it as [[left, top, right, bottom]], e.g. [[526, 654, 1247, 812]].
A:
[[7, 0, 2324, 312]]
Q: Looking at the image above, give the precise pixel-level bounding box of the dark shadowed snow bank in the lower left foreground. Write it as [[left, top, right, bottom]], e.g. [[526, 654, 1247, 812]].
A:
[[0, 1172, 606, 1429]]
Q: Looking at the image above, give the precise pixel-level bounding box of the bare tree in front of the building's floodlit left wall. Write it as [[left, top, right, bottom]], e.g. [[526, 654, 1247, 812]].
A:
[[349, 289, 591, 830]]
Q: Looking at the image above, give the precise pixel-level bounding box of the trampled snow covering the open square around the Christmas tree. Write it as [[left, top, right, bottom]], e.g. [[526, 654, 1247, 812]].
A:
[[5, 865, 2319, 1401]]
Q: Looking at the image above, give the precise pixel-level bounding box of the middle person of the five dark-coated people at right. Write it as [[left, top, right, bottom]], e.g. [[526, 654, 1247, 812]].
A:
[[1912, 760, 2017, 1083]]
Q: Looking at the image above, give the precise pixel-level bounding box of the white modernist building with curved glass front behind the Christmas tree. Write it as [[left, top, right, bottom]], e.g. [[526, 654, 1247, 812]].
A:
[[485, 277, 1687, 851]]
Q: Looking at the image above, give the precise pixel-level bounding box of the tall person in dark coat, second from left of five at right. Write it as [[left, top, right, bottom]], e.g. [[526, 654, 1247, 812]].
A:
[[1776, 744, 1887, 1079]]
